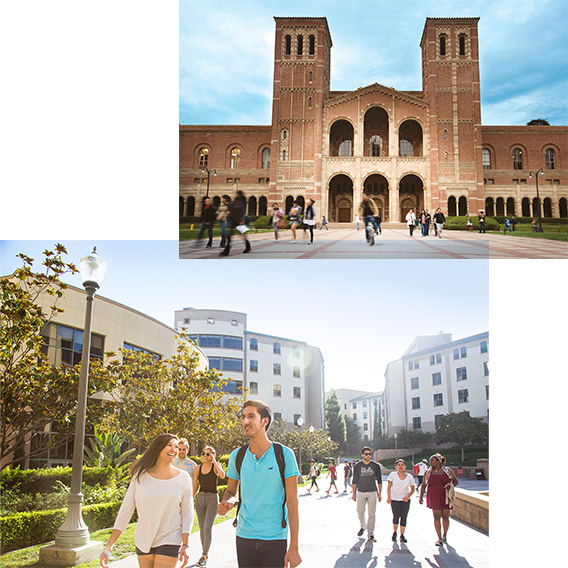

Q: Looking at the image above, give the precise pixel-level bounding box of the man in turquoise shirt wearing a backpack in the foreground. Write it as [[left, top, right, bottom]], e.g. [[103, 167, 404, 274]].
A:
[[217, 400, 302, 568]]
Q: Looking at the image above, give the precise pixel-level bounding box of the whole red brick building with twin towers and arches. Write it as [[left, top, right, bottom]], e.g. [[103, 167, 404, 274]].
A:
[[179, 18, 568, 222]]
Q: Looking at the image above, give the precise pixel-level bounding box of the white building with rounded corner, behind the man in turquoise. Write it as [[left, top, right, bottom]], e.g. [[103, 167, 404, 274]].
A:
[[175, 308, 325, 428]]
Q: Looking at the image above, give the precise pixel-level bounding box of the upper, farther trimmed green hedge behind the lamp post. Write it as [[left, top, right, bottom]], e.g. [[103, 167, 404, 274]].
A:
[[2, 467, 115, 493]]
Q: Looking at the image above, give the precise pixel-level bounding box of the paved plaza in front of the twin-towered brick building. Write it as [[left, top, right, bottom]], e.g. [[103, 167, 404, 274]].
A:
[[179, 227, 568, 260]]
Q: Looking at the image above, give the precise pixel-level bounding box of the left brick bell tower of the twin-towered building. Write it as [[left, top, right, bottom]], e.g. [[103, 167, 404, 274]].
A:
[[269, 18, 332, 209]]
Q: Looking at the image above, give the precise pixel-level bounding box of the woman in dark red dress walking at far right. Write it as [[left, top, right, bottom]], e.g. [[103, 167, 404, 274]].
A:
[[419, 454, 458, 546]]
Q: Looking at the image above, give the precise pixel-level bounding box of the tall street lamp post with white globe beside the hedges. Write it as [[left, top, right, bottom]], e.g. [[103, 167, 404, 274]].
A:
[[40, 247, 106, 566]]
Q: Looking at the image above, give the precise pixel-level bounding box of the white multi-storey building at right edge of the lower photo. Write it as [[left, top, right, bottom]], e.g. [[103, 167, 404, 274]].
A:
[[384, 332, 489, 437]]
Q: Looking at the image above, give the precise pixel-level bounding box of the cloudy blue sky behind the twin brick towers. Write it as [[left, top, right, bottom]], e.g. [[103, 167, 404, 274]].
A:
[[179, 0, 568, 125]]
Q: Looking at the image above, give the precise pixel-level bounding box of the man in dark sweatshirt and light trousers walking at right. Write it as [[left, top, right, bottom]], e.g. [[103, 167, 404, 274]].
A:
[[353, 446, 383, 542]]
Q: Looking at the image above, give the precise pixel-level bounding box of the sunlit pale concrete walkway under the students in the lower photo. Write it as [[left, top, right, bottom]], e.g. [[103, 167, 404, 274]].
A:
[[111, 477, 489, 568]]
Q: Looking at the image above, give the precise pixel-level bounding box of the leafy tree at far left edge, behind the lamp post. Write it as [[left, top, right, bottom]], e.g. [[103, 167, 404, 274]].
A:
[[0, 244, 116, 467]]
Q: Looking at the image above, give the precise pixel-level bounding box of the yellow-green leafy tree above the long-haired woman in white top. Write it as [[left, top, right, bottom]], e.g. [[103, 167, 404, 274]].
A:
[[97, 335, 242, 447]]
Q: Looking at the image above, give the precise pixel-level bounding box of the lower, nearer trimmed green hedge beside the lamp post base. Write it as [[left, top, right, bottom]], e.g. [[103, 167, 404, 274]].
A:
[[0, 501, 124, 553]]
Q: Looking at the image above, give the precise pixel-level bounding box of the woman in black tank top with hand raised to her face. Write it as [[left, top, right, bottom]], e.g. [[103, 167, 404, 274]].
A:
[[193, 446, 225, 566]]
